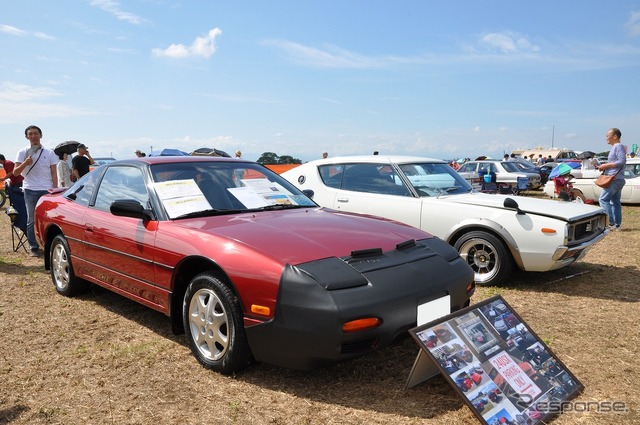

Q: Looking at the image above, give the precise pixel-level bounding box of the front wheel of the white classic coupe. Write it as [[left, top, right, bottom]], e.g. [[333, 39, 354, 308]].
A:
[[454, 231, 513, 286]]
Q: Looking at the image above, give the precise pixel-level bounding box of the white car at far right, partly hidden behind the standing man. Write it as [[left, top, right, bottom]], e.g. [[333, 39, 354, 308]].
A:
[[544, 158, 640, 204]]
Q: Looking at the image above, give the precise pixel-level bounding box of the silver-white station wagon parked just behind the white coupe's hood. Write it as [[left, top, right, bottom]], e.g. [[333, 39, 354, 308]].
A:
[[458, 159, 542, 189]]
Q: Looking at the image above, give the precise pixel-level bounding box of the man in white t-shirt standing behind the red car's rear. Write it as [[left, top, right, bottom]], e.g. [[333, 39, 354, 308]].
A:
[[13, 125, 58, 257]]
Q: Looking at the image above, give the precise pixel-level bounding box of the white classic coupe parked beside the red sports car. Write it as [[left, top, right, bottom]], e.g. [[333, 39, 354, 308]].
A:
[[282, 155, 607, 285]]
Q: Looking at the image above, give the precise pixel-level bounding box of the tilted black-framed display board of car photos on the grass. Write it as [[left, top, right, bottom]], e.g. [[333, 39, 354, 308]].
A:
[[410, 295, 584, 425]]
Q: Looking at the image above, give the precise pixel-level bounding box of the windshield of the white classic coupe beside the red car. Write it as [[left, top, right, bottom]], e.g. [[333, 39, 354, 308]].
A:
[[400, 162, 473, 196]]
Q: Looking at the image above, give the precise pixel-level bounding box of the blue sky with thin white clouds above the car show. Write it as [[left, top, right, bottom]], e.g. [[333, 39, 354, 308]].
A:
[[0, 0, 640, 161]]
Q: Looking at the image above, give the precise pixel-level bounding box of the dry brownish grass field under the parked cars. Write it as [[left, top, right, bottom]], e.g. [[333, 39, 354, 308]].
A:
[[0, 200, 640, 425]]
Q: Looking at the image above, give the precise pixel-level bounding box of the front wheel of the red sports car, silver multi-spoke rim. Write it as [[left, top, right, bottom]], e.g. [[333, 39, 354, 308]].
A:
[[182, 272, 251, 374]]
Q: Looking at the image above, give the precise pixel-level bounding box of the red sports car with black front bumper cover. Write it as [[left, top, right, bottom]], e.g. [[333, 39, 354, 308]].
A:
[[36, 156, 474, 373]]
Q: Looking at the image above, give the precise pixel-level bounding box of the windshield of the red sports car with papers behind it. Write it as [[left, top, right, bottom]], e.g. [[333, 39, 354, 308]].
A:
[[151, 161, 316, 218]]
